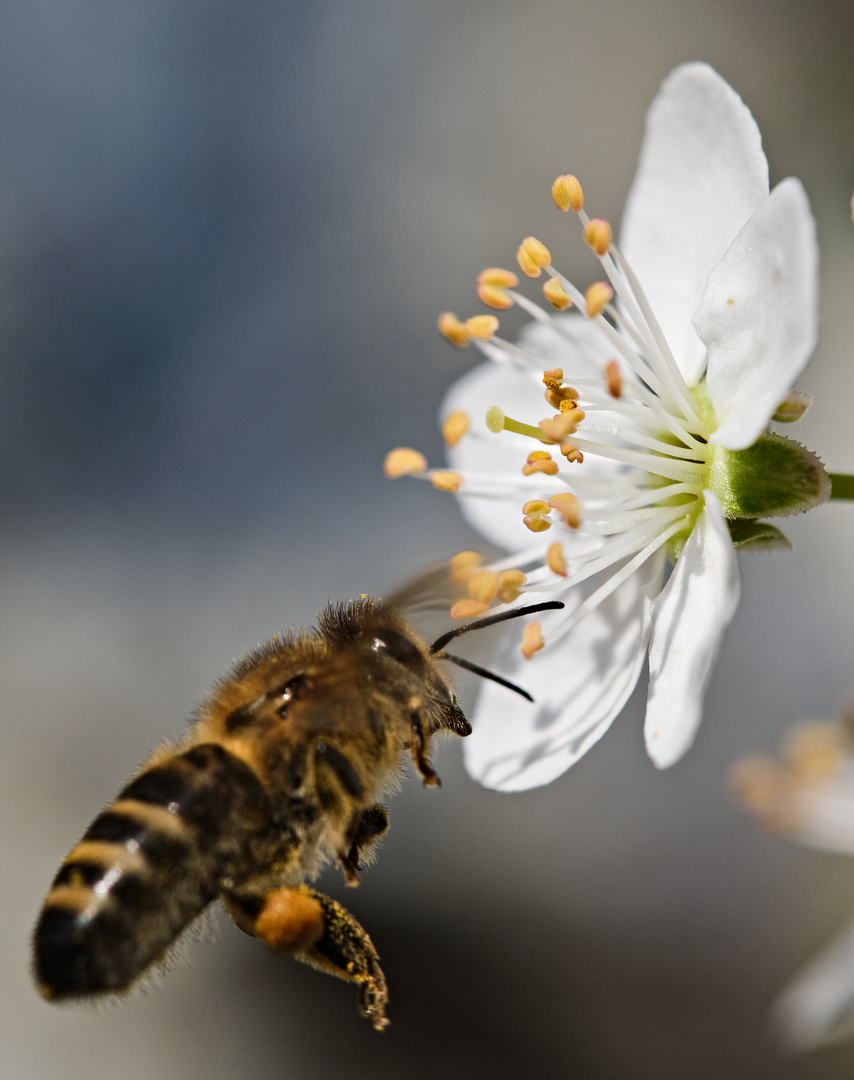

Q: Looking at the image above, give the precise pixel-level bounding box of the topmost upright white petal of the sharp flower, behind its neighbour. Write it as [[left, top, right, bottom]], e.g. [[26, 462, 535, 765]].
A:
[[622, 64, 768, 386]]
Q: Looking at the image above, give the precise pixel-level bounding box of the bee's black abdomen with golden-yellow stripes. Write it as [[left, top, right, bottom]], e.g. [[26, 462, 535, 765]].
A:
[[35, 743, 270, 999]]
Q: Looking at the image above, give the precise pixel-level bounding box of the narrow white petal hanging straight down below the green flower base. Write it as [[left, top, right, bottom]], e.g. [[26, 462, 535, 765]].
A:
[[643, 491, 741, 769]]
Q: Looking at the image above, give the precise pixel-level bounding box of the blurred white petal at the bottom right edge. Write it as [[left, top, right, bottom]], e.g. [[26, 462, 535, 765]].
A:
[[774, 926, 854, 1050]]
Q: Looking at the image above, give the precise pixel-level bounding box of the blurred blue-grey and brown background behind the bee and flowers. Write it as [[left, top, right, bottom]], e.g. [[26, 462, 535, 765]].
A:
[[0, 0, 854, 1080]]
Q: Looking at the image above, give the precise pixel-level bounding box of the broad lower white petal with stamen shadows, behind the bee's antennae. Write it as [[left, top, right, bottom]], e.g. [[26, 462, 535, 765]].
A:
[[464, 552, 664, 792]]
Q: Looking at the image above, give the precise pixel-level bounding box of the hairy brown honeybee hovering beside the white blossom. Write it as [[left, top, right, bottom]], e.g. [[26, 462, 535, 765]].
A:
[[33, 598, 562, 1030]]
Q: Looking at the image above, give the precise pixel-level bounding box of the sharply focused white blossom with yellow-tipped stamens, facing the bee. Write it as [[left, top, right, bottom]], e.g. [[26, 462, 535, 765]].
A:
[[390, 64, 829, 791]]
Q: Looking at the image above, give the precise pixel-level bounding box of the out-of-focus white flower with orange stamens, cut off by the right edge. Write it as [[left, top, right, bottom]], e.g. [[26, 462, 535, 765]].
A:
[[730, 715, 854, 1050]]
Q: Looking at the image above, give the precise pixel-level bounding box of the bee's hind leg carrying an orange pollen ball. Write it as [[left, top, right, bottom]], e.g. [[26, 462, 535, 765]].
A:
[[223, 885, 389, 1031]]
